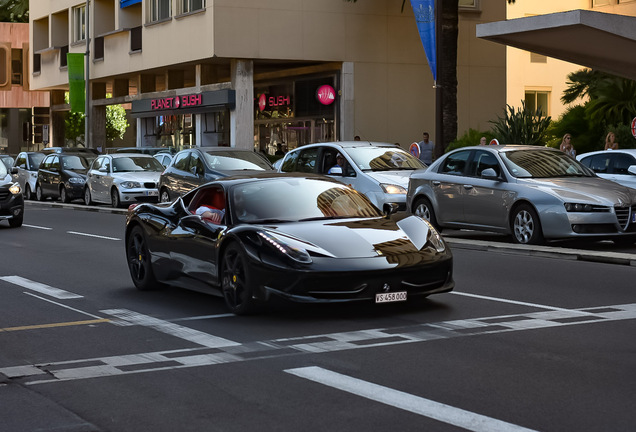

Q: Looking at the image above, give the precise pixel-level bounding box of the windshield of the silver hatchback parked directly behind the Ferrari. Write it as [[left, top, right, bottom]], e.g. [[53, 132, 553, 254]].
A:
[[340, 147, 426, 171]]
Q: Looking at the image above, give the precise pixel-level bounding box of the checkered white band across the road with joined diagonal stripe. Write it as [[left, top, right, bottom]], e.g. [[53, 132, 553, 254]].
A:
[[0, 303, 636, 385]]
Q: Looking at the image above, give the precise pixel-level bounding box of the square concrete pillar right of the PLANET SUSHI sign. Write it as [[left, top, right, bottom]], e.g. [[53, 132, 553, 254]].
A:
[[230, 59, 254, 150]]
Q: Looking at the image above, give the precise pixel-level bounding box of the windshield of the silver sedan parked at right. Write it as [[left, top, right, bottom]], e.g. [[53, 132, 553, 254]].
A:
[[500, 149, 595, 178]]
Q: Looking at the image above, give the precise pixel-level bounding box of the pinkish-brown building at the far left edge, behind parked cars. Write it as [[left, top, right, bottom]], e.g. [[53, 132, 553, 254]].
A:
[[0, 22, 49, 155]]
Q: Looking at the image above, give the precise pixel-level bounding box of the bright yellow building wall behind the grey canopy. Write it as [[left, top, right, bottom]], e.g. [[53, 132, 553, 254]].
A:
[[506, 0, 636, 120]]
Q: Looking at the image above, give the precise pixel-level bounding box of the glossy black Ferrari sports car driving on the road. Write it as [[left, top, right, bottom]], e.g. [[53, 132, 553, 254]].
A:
[[126, 173, 454, 314]]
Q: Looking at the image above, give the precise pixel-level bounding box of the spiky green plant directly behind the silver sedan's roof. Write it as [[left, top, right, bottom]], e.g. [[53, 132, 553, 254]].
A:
[[490, 101, 551, 145]]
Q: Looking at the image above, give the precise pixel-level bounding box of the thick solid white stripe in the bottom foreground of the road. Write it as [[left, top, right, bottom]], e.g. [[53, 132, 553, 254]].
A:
[[285, 366, 532, 432]]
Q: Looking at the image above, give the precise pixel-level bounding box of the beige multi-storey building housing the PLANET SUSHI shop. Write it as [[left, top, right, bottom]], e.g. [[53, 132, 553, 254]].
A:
[[30, 0, 506, 154]]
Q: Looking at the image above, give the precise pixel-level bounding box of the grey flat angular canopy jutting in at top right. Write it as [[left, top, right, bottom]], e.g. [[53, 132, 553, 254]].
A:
[[477, 10, 636, 80]]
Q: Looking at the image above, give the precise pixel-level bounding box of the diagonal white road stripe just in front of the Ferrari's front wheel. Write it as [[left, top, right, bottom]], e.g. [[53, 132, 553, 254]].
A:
[[100, 309, 241, 348]]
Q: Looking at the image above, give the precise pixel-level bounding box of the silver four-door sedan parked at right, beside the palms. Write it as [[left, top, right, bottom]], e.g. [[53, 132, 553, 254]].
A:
[[407, 145, 636, 244]]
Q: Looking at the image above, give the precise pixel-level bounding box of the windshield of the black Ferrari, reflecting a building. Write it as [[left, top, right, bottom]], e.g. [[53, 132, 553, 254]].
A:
[[230, 178, 382, 223]]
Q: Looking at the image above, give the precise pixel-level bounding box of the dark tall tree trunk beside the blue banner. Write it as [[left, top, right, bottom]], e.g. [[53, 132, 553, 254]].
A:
[[345, 0, 515, 157]]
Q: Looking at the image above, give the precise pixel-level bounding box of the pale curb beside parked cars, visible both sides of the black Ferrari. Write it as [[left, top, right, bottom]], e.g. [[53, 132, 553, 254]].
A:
[[25, 201, 636, 267]]
